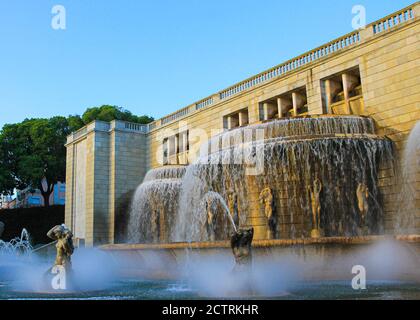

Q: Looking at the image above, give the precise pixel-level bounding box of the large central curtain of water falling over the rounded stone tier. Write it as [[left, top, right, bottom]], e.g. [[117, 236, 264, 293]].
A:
[[174, 116, 393, 241]]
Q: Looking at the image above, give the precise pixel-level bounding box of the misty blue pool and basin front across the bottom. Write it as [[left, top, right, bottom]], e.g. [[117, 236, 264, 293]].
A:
[[0, 237, 420, 299]]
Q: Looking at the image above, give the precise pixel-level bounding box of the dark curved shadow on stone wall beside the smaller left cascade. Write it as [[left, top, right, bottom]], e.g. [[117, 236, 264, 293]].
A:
[[114, 190, 135, 243]]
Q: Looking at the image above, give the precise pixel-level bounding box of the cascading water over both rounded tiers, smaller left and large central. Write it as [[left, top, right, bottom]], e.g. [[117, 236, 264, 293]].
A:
[[128, 115, 393, 243]]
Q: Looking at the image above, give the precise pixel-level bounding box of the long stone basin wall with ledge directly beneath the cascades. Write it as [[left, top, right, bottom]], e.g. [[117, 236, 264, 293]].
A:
[[100, 235, 420, 283]]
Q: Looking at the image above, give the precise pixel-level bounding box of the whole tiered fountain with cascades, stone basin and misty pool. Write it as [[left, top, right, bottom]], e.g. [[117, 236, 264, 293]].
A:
[[0, 116, 420, 299]]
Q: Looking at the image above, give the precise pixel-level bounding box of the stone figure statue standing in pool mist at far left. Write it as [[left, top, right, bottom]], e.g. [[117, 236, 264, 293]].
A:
[[47, 224, 74, 271]]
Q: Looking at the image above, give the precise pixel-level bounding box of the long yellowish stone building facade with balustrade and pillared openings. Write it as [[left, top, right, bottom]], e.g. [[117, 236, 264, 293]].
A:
[[66, 3, 420, 245]]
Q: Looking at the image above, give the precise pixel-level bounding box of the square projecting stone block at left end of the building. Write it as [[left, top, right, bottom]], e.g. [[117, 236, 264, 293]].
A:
[[65, 121, 148, 246]]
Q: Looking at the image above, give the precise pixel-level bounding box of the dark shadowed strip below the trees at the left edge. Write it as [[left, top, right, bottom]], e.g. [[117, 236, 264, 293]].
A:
[[0, 206, 64, 246]]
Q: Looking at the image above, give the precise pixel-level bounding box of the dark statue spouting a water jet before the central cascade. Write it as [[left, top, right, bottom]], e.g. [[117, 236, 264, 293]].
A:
[[230, 228, 254, 272]]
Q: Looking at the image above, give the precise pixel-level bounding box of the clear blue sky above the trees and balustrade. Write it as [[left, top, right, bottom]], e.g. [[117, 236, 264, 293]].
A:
[[0, 0, 415, 127]]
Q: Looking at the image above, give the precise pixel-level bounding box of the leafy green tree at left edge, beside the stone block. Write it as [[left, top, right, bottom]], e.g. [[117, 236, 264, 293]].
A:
[[0, 117, 80, 206]]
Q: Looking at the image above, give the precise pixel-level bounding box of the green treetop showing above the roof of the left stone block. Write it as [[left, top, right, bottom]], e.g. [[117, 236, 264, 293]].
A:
[[82, 105, 154, 124]]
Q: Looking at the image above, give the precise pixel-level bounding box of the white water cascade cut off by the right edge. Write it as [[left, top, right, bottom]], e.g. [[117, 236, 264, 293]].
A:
[[396, 122, 420, 234]]
